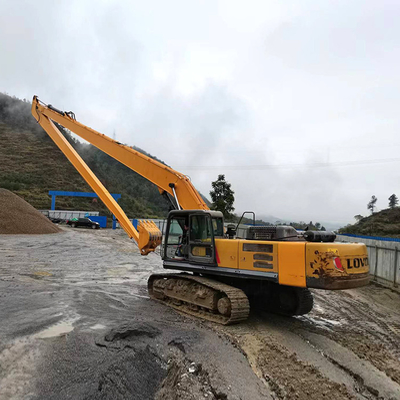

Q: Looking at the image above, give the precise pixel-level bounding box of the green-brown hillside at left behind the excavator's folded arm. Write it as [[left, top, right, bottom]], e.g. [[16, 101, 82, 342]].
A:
[[0, 93, 206, 218]]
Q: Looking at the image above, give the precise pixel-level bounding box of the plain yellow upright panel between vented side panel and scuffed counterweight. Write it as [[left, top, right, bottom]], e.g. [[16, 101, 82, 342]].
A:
[[277, 242, 306, 287]]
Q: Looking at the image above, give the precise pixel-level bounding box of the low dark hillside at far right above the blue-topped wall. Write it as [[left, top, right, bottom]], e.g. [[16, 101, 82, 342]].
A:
[[340, 207, 400, 238]]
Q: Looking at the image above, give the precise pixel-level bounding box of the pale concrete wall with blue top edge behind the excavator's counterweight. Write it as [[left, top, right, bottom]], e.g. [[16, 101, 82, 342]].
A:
[[336, 235, 400, 290]]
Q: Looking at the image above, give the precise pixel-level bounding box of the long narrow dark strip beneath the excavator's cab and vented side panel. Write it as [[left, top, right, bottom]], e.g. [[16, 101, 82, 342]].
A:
[[163, 261, 278, 282]]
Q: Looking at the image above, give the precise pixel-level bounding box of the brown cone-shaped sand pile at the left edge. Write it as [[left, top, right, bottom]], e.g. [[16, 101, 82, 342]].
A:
[[0, 188, 61, 234]]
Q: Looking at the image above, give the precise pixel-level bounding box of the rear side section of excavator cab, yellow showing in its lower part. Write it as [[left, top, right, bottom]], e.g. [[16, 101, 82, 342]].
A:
[[189, 213, 217, 265]]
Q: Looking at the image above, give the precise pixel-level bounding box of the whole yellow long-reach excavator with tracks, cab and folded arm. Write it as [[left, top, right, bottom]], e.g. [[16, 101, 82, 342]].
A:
[[32, 96, 369, 324]]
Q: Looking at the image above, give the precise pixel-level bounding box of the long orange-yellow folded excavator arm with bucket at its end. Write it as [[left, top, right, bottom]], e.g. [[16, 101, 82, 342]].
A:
[[32, 96, 208, 255]]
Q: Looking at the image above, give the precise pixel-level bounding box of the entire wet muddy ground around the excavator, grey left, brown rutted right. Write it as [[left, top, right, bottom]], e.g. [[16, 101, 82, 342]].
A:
[[0, 228, 400, 400]]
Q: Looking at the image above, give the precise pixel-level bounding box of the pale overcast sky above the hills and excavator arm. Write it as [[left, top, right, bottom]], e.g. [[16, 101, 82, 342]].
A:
[[0, 0, 400, 223]]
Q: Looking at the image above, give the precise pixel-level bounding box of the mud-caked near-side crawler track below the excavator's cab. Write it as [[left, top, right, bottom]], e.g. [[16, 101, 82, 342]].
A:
[[148, 274, 250, 325]]
